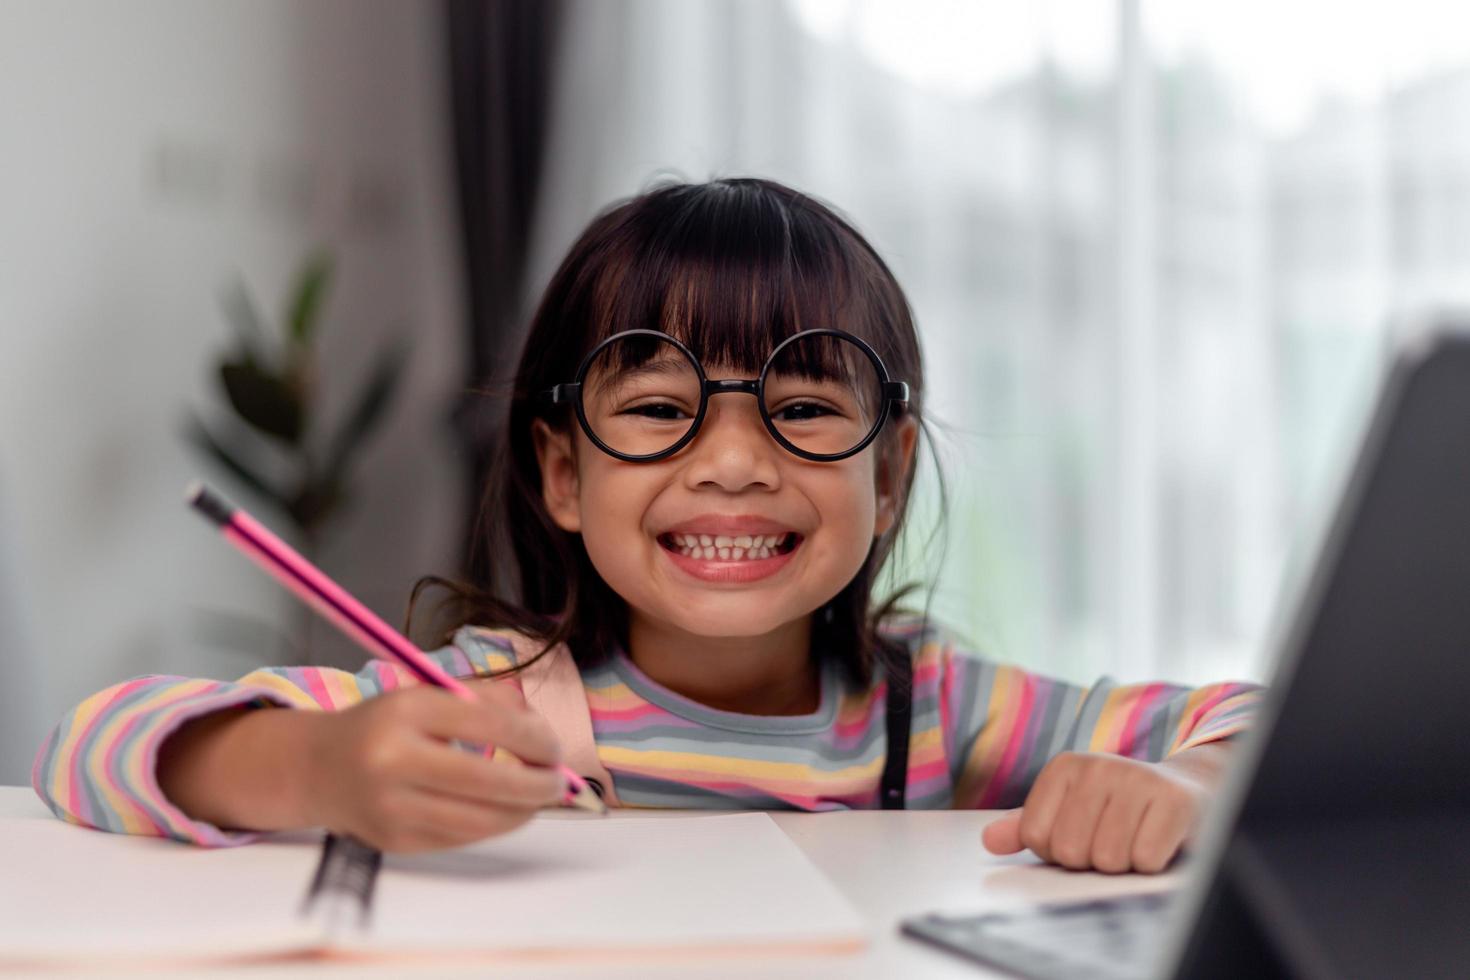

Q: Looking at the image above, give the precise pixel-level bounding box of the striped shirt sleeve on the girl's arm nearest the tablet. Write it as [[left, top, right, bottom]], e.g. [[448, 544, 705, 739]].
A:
[[938, 646, 1264, 810]]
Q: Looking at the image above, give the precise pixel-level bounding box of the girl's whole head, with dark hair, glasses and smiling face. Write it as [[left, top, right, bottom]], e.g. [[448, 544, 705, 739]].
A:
[[476, 178, 925, 696]]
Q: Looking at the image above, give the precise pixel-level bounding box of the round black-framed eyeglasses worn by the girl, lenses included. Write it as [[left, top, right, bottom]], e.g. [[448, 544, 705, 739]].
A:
[[541, 329, 908, 463]]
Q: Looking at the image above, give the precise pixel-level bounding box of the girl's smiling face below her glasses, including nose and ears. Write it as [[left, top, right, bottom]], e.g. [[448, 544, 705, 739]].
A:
[[534, 367, 917, 638]]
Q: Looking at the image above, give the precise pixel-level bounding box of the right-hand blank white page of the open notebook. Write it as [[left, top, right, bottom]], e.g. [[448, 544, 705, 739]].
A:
[[358, 813, 864, 952]]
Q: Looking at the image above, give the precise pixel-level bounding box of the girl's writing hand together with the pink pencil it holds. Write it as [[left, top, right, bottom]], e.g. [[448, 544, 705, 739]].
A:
[[179, 483, 606, 851]]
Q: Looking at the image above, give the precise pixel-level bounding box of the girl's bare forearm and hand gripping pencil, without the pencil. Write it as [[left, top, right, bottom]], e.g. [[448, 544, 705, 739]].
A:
[[157, 683, 566, 851]]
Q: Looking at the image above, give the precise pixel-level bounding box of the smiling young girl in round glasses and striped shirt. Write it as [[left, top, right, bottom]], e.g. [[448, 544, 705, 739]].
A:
[[34, 179, 1258, 871]]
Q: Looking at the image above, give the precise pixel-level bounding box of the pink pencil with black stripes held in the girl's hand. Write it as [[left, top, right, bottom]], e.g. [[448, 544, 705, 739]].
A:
[[185, 480, 607, 813]]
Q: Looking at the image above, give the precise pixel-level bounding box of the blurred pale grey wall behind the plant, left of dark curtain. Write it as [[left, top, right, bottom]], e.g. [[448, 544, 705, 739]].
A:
[[0, 0, 462, 783]]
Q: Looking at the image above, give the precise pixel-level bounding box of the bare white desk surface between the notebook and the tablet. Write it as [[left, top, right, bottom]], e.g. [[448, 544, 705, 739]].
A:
[[0, 786, 1180, 980]]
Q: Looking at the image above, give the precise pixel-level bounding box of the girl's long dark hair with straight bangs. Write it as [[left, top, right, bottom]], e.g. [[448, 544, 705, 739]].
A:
[[407, 178, 942, 685]]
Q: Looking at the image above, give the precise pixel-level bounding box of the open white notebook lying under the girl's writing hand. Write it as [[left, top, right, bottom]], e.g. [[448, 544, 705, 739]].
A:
[[0, 811, 866, 970]]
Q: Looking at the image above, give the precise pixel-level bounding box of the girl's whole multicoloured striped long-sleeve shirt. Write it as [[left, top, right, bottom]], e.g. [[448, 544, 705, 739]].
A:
[[32, 620, 1261, 845]]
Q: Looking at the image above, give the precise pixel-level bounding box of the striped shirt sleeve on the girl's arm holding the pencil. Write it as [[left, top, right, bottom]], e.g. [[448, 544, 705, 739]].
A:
[[31, 630, 523, 846]]
